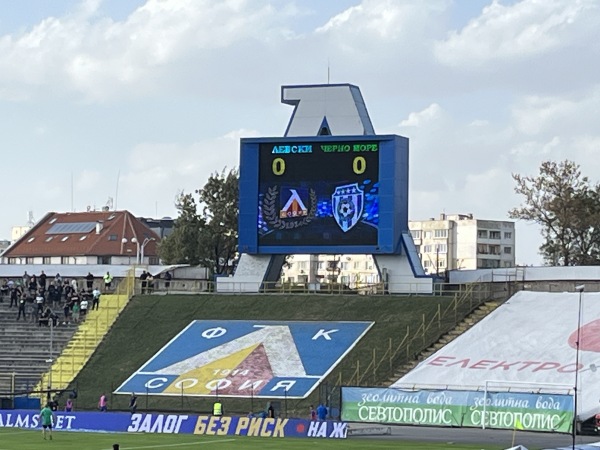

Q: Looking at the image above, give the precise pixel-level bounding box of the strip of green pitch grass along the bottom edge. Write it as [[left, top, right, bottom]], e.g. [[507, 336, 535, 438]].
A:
[[0, 428, 506, 450]]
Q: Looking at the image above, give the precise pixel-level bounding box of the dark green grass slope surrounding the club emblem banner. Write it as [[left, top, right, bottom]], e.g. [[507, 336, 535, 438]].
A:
[[68, 295, 469, 416]]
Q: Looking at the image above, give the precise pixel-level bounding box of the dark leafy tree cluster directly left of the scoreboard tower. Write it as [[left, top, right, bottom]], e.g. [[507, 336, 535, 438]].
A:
[[159, 169, 239, 274]]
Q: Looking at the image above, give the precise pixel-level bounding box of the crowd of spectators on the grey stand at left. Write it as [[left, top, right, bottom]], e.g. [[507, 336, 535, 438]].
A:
[[0, 270, 102, 327]]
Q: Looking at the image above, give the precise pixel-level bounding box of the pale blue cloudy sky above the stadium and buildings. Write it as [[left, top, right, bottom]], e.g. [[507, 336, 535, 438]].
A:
[[0, 0, 600, 264]]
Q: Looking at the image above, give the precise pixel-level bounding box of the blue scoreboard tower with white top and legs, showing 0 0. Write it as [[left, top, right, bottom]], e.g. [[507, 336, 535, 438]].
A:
[[217, 84, 432, 293]]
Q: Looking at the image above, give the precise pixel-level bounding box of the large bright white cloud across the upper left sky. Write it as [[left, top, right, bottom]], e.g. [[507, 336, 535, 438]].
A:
[[0, 0, 298, 101]]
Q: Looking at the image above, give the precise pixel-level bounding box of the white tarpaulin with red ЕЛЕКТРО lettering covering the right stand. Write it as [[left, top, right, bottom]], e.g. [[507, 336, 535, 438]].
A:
[[392, 291, 600, 419]]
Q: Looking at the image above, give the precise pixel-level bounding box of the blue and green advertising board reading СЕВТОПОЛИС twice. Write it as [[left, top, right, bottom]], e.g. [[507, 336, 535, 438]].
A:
[[342, 388, 573, 433]]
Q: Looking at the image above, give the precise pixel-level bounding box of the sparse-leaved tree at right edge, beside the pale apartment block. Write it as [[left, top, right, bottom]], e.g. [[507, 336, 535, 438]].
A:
[[509, 160, 600, 266]]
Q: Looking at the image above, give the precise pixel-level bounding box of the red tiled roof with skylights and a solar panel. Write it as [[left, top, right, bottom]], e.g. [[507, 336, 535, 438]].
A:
[[2, 211, 160, 257]]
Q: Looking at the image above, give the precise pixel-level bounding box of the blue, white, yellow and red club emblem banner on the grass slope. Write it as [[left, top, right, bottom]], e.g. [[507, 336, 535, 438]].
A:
[[115, 320, 373, 398]]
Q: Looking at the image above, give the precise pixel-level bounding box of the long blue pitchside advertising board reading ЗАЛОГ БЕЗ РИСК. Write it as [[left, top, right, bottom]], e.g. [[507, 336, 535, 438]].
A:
[[0, 409, 348, 439]]
